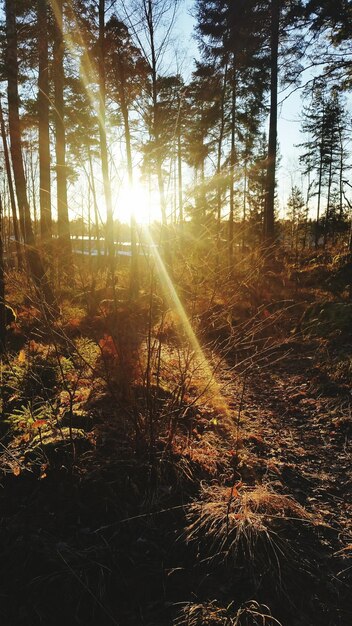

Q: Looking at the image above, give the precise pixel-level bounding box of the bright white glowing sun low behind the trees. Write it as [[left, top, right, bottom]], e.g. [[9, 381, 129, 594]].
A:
[[114, 183, 161, 225]]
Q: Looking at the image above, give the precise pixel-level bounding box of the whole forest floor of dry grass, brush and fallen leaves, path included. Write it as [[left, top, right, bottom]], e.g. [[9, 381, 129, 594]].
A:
[[0, 250, 352, 626]]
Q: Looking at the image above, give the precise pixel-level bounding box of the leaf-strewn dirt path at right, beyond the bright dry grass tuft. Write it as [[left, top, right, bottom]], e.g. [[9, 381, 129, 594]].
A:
[[245, 344, 352, 534]]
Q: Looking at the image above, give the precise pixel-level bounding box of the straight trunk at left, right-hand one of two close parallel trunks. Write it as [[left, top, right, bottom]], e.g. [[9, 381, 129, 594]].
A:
[[53, 0, 72, 275]]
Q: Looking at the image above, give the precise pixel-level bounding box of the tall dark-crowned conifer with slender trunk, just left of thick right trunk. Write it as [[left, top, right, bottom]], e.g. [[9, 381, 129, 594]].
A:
[[196, 0, 268, 258]]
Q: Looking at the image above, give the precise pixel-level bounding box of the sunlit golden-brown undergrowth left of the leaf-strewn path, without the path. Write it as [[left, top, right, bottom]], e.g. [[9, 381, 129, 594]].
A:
[[0, 245, 351, 626]]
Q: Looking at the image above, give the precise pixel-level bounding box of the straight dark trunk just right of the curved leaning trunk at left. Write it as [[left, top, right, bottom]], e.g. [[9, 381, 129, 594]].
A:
[[38, 0, 52, 244]]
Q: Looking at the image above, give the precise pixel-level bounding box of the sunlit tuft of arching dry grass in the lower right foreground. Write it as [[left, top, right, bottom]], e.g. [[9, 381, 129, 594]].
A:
[[186, 485, 314, 593]]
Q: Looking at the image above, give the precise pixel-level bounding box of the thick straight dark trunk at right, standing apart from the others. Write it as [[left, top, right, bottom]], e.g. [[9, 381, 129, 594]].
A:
[[264, 0, 280, 244]]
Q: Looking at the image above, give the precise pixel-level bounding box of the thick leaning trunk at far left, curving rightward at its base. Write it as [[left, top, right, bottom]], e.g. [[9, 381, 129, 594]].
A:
[[5, 0, 54, 306]]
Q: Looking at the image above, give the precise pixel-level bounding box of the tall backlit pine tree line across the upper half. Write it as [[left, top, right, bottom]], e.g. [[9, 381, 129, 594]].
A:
[[0, 0, 352, 304]]
